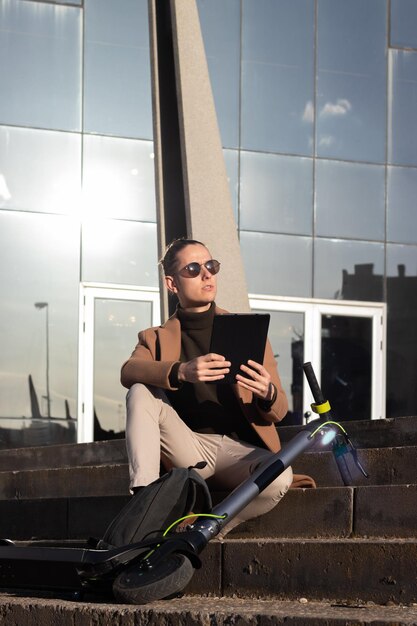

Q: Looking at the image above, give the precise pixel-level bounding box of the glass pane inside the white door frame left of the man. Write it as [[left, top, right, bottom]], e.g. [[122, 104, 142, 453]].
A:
[[94, 298, 152, 441]]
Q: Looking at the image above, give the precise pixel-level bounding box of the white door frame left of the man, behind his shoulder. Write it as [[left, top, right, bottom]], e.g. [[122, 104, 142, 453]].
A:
[[77, 282, 161, 443]]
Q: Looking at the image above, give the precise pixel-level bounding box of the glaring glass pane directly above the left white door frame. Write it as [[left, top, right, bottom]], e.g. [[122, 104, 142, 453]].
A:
[[82, 219, 158, 287]]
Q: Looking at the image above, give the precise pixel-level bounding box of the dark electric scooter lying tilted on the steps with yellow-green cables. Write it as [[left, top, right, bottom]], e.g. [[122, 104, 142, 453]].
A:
[[0, 363, 367, 604]]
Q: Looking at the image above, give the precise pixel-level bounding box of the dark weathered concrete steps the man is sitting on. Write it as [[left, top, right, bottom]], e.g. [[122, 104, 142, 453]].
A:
[[0, 418, 417, 626]]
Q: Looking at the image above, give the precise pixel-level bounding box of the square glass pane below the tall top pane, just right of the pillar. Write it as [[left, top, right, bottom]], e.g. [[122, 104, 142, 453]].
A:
[[240, 152, 313, 235]]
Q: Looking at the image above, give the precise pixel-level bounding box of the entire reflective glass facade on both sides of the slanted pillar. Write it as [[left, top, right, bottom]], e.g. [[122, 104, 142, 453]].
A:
[[0, 0, 417, 447]]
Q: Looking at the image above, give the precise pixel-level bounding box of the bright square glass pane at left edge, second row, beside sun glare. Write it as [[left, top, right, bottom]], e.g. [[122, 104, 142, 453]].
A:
[[0, 126, 81, 214]]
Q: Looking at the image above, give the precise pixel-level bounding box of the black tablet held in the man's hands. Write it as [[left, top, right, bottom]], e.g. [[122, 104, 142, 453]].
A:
[[210, 313, 270, 384]]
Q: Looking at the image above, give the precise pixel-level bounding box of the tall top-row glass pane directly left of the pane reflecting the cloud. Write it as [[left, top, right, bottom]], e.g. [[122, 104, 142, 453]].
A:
[[241, 0, 314, 155]]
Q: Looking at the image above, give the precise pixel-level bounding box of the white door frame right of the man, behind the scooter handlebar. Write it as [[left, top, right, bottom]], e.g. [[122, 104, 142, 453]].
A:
[[249, 294, 387, 419]]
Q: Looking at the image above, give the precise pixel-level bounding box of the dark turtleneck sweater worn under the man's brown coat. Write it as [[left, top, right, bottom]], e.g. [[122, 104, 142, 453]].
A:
[[167, 303, 263, 446]]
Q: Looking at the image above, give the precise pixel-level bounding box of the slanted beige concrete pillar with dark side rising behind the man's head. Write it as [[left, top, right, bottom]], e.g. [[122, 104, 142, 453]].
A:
[[149, 0, 249, 319]]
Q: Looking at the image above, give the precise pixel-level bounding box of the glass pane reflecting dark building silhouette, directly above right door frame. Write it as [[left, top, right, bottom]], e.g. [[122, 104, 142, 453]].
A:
[[314, 239, 384, 302]]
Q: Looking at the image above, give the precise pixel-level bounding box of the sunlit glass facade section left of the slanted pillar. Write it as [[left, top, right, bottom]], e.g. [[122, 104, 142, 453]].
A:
[[0, 0, 158, 447]]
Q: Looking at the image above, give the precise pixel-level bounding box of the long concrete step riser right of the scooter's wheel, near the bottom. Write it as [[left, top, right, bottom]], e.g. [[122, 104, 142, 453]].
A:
[[223, 539, 417, 604]]
